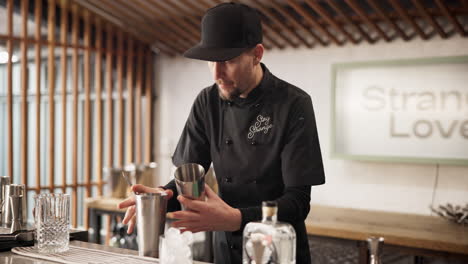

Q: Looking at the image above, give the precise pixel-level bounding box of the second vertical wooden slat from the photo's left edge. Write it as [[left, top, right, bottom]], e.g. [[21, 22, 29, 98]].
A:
[[21, 0, 29, 186]]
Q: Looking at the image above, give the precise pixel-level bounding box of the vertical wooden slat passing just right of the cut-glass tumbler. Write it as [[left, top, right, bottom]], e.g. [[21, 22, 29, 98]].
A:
[[71, 4, 80, 227]]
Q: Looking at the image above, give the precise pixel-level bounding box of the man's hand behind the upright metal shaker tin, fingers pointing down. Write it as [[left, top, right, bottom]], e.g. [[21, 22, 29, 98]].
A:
[[118, 184, 173, 234]]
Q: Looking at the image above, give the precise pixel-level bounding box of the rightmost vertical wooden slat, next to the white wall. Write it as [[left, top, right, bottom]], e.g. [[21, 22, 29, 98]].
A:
[[145, 49, 154, 163]]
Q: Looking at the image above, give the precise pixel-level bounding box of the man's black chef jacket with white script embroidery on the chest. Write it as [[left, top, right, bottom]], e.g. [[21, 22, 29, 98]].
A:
[[165, 64, 325, 264]]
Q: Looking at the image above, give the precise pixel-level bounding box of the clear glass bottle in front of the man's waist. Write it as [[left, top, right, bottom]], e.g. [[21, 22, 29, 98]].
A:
[[242, 201, 296, 264]]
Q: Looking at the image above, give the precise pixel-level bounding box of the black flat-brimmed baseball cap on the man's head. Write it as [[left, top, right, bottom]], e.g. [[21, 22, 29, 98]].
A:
[[184, 3, 262, 61]]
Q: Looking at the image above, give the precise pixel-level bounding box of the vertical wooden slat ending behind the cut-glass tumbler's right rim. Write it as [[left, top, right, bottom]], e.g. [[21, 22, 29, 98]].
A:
[[60, 0, 68, 193]]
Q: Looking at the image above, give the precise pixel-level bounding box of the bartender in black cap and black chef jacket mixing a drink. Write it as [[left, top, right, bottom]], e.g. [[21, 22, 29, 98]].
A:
[[119, 3, 325, 264]]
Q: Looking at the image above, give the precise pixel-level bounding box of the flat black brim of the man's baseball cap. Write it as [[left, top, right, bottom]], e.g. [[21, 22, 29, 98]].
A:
[[184, 44, 248, 61]]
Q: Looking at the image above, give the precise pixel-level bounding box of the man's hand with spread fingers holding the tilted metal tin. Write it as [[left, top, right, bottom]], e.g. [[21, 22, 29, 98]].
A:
[[167, 184, 242, 233]]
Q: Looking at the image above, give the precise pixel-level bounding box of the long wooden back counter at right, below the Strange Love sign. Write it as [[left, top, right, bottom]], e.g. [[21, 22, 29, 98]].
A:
[[306, 205, 468, 264]]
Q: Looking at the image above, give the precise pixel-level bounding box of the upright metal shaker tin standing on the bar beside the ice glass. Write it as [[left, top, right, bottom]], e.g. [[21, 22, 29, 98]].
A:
[[136, 193, 167, 258]]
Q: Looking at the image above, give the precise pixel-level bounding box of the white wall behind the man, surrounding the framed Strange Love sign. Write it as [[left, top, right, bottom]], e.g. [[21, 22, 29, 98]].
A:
[[155, 36, 468, 214]]
